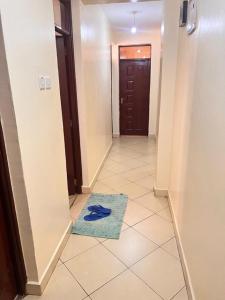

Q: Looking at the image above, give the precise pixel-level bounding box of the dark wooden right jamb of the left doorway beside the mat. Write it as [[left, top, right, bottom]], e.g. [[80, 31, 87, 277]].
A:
[[55, 0, 83, 194]]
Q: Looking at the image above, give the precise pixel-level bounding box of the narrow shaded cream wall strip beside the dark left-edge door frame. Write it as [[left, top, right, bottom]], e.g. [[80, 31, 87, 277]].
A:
[[0, 14, 38, 280]]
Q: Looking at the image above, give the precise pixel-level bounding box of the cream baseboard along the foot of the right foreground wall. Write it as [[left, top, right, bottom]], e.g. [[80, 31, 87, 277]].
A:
[[168, 193, 196, 300]]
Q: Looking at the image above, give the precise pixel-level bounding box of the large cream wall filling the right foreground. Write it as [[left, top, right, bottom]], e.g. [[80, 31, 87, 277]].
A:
[[157, 0, 225, 300]]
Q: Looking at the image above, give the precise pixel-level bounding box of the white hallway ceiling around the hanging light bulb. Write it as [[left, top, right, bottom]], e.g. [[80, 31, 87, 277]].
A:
[[102, 1, 163, 32]]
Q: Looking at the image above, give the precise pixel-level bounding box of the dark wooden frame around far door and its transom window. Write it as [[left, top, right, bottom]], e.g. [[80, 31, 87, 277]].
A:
[[118, 44, 152, 135]]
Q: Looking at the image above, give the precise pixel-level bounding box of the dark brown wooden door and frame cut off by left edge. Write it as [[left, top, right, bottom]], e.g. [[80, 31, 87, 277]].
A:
[[0, 124, 26, 300]]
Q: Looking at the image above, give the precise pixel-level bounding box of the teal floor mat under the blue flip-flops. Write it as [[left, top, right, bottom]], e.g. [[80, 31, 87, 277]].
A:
[[72, 194, 128, 239]]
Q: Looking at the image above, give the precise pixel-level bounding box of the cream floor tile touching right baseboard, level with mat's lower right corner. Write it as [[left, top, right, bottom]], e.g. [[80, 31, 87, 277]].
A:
[[134, 215, 174, 245]]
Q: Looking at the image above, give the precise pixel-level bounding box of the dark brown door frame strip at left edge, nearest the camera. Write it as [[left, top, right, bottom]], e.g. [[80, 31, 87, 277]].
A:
[[0, 123, 27, 295]]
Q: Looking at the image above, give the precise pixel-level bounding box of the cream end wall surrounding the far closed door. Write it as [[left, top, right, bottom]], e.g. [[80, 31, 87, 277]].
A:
[[113, 30, 161, 135]]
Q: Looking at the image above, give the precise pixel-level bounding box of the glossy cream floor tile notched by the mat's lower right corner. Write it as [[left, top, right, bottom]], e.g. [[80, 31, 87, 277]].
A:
[[103, 228, 158, 266]]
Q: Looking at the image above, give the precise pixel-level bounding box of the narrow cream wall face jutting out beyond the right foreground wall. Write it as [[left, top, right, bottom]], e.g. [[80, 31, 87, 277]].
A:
[[155, 0, 180, 191]]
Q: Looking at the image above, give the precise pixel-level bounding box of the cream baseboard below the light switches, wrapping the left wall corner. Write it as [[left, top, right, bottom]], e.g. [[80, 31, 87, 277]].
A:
[[26, 221, 72, 296]]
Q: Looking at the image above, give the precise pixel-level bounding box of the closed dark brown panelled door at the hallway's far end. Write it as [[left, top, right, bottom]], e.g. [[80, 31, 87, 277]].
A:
[[120, 59, 151, 135]]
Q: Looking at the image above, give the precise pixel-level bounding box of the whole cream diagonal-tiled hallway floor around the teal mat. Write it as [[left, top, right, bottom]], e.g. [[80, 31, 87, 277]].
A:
[[26, 137, 188, 300]]
